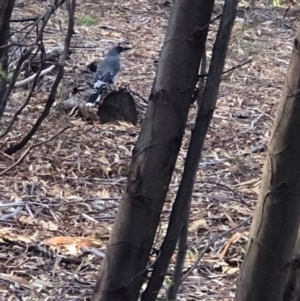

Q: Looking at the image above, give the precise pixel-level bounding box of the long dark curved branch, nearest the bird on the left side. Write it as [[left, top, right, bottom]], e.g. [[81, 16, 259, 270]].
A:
[[5, 0, 76, 155]]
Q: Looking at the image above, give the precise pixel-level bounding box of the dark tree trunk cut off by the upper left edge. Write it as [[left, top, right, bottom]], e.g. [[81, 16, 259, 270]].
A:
[[0, 0, 15, 118]]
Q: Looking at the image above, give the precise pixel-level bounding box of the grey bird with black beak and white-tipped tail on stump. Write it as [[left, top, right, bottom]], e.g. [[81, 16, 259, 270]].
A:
[[86, 45, 131, 106]]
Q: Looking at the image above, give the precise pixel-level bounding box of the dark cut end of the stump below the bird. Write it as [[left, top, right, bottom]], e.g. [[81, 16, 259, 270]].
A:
[[98, 89, 138, 125]]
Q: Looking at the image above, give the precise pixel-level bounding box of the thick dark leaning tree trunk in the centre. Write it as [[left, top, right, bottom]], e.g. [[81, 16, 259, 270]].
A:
[[92, 0, 213, 301]]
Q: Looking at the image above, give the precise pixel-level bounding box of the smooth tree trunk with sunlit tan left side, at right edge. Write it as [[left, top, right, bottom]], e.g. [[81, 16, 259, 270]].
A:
[[236, 30, 300, 301]]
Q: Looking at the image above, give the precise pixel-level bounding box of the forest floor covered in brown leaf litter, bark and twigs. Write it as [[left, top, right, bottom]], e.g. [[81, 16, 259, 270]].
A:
[[0, 0, 297, 301]]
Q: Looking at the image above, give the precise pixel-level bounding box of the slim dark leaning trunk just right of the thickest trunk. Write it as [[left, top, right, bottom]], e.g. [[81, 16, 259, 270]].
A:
[[142, 0, 238, 301]]
